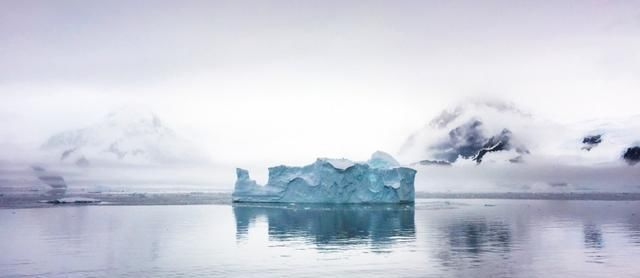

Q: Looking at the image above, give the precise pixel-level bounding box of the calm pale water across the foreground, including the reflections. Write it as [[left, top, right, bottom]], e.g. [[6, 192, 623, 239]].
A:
[[0, 200, 640, 277]]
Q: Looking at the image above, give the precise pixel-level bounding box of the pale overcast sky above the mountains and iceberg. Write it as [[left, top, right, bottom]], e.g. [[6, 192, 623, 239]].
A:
[[0, 0, 640, 163]]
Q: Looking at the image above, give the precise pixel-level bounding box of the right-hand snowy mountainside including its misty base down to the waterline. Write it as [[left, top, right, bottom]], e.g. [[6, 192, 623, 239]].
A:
[[397, 102, 640, 192]]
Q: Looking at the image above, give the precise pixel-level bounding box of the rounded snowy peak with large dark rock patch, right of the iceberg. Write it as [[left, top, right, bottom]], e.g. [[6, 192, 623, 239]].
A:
[[400, 102, 533, 165]]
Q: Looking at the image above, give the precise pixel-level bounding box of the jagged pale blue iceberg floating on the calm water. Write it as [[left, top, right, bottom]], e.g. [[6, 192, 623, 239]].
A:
[[232, 152, 416, 204]]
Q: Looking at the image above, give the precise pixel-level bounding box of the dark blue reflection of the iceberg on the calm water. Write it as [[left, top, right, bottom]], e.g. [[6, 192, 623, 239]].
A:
[[233, 204, 416, 248]]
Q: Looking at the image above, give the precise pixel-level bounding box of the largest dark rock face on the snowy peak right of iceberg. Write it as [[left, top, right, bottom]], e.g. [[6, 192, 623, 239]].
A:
[[430, 119, 528, 163]]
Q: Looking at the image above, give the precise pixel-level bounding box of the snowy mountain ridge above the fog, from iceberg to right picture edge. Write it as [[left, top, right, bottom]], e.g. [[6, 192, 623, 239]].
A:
[[399, 102, 640, 165]]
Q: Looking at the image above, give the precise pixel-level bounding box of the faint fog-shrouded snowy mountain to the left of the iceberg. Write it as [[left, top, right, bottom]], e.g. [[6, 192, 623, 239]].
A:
[[40, 108, 207, 167]]
